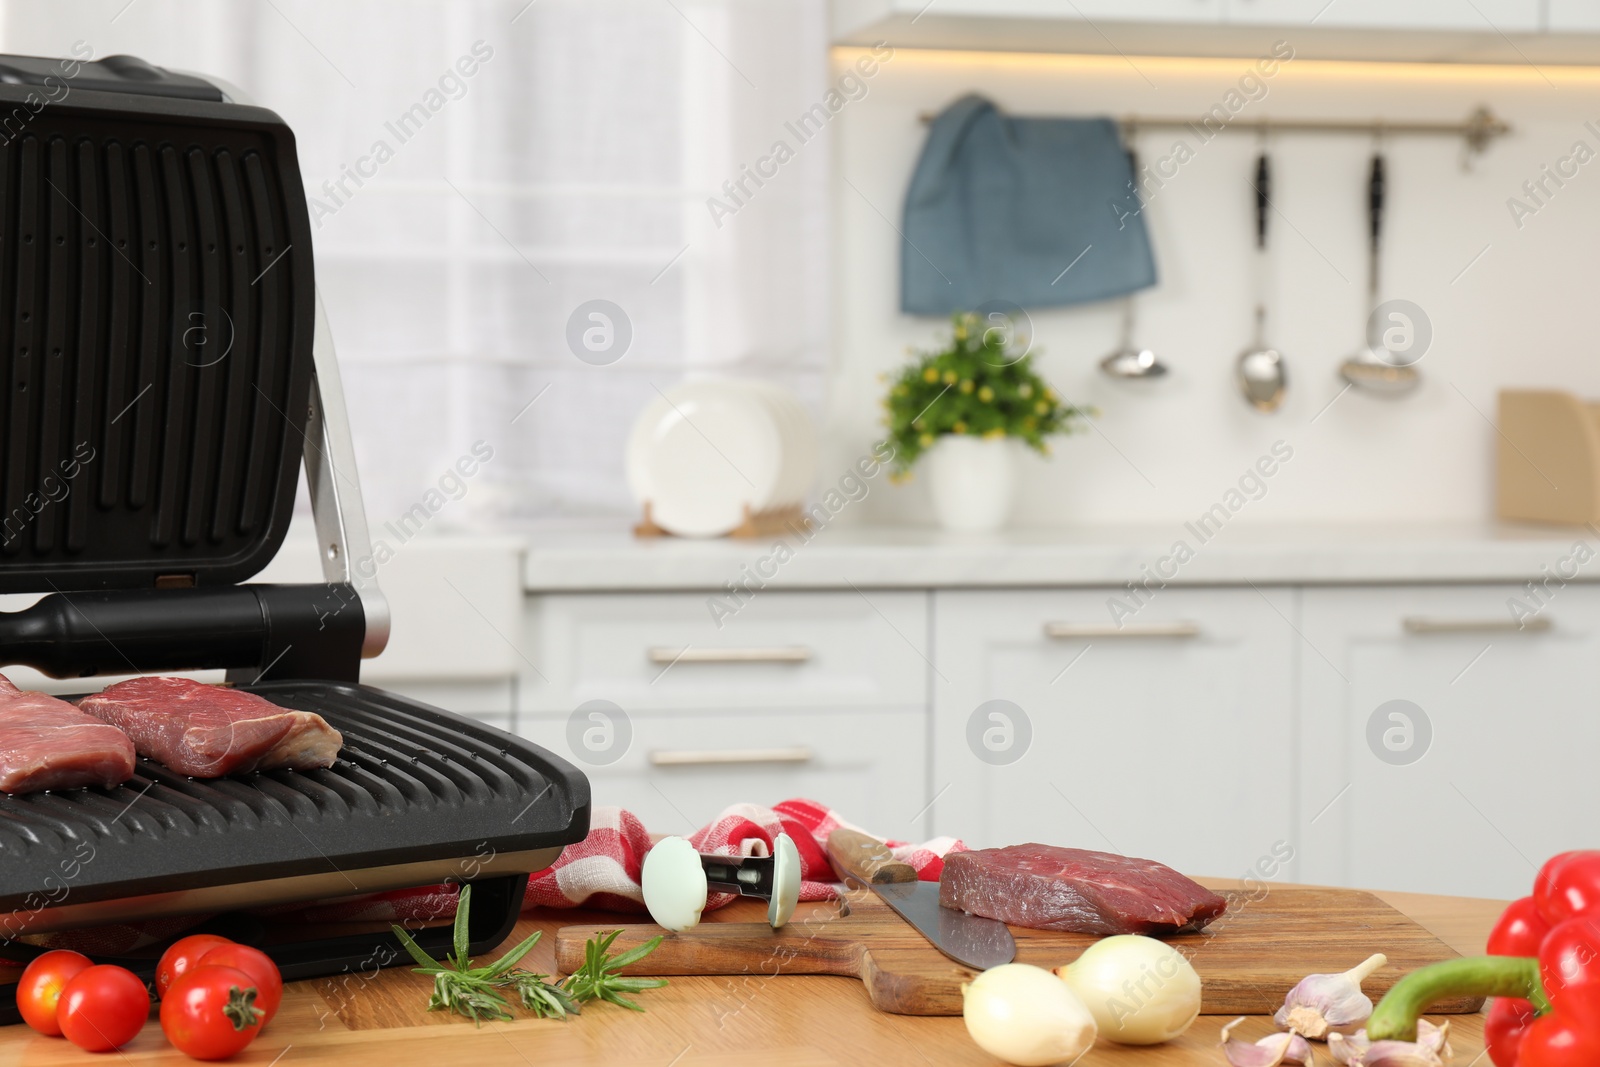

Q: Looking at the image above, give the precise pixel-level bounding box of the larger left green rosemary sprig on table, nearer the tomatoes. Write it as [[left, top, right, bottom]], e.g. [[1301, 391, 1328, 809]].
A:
[[390, 886, 579, 1025]]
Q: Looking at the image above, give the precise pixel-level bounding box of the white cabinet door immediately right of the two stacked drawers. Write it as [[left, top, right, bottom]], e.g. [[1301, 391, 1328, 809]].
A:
[[930, 589, 1298, 878]]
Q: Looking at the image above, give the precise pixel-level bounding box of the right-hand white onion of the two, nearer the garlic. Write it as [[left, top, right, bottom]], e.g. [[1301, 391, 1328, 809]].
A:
[[1056, 934, 1200, 1045]]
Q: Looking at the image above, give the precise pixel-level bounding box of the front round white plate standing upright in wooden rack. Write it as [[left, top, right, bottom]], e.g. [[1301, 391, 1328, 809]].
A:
[[627, 382, 787, 537]]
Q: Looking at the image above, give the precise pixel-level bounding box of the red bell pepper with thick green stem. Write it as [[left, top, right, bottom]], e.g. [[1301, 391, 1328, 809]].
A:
[[1366, 851, 1600, 1067]]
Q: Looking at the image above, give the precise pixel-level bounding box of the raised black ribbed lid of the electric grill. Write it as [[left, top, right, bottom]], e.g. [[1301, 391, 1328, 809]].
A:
[[0, 56, 315, 592]]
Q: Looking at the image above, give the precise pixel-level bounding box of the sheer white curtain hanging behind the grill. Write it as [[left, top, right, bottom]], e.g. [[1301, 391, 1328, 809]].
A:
[[0, 0, 829, 526]]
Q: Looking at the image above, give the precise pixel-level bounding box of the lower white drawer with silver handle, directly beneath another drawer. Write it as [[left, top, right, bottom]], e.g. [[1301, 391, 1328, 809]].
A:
[[518, 710, 931, 838]]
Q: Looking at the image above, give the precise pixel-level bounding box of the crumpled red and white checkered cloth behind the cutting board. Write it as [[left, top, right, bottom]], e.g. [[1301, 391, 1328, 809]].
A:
[[24, 800, 966, 955]]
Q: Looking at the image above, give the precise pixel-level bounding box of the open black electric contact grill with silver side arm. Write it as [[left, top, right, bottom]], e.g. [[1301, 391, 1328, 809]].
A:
[[0, 56, 589, 1019]]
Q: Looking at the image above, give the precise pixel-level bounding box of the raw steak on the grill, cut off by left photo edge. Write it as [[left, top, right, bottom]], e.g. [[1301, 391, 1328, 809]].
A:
[[0, 675, 134, 793]]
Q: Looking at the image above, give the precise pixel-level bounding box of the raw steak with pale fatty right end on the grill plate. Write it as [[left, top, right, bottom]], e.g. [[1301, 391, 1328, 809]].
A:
[[78, 678, 344, 777]]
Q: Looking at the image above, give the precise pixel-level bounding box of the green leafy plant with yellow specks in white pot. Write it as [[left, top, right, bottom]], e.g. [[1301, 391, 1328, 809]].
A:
[[883, 312, 1091, 531]]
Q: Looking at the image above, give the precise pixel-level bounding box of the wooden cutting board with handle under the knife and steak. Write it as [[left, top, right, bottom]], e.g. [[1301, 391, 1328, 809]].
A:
[[555, 889, 1483, 1016]]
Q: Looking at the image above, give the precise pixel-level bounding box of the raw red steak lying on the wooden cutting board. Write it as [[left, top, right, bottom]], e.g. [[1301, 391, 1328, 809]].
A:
[[939, 845, 1227, 937]]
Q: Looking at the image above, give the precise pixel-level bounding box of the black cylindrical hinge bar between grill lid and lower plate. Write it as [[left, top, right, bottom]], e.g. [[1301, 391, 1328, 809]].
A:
[[0, 584, 365, 683]]
